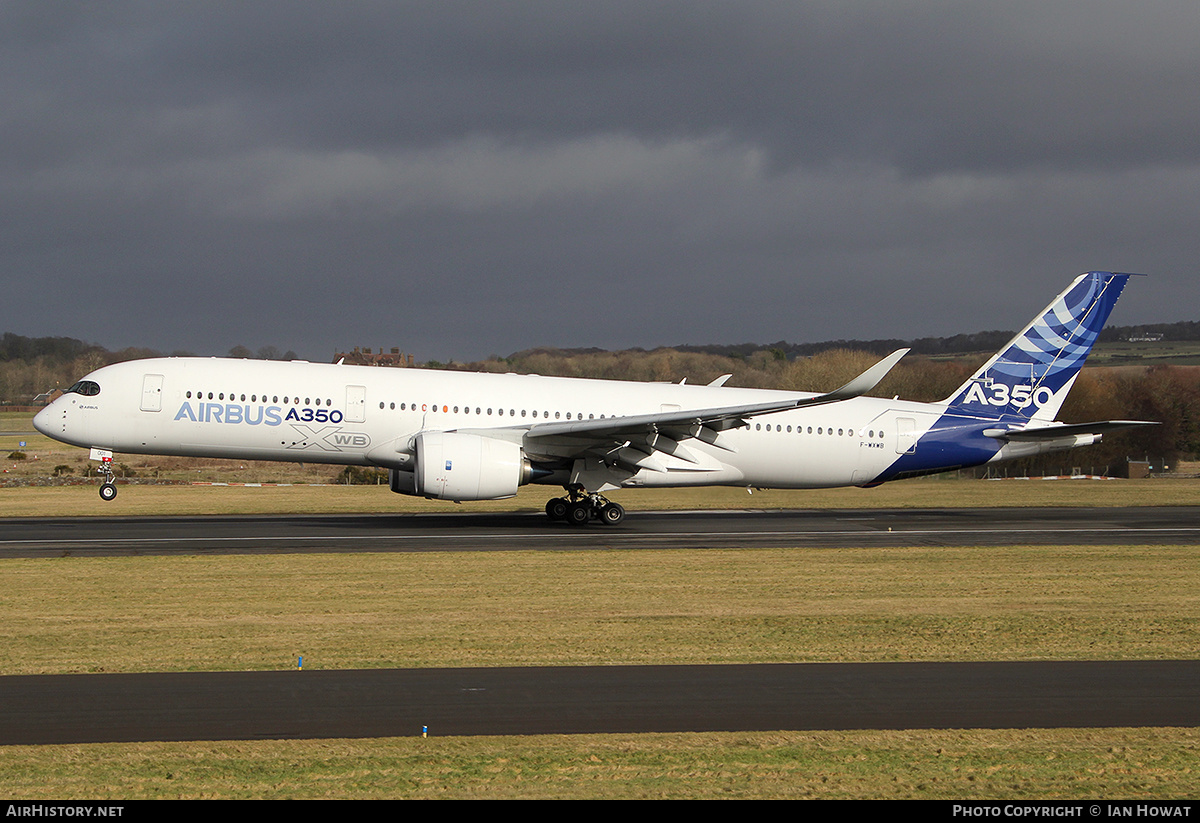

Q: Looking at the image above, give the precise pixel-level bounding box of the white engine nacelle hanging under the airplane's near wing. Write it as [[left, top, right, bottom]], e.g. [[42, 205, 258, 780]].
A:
[[389, 432, 532, 500]]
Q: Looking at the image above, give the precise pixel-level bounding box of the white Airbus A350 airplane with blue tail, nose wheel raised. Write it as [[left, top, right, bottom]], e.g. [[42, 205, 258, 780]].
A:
[[34, 271, 1154, 525]]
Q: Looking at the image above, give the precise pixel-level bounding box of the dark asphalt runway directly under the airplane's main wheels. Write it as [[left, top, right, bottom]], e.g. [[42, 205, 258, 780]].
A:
[[0, 506, 1200, 558]]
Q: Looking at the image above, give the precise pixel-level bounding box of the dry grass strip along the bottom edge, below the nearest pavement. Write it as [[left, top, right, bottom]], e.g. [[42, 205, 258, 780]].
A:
[[0, 728, 1200, 803]]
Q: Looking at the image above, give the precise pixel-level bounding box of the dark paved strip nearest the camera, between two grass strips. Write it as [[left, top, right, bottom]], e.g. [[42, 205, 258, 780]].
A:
[[0, 661, 1200, 745]]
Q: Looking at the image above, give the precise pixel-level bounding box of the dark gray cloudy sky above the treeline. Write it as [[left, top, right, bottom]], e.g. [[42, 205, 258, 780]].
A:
[[0, 0, 1200, 360]]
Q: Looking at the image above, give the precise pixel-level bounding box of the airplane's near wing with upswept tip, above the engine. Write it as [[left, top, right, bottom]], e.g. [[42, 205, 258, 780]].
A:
[[526, 349, 908, 439]]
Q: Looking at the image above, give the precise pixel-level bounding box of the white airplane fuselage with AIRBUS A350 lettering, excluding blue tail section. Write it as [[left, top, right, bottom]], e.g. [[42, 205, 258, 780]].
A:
[[36, 358, 944, 488]]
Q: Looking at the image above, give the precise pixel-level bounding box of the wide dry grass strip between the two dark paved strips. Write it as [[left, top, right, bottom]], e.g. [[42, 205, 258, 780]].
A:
[[0, 546, 1200, 674]]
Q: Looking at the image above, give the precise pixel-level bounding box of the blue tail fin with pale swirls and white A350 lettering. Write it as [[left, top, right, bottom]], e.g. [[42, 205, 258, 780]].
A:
[[946, 271, 1130, 420]]
